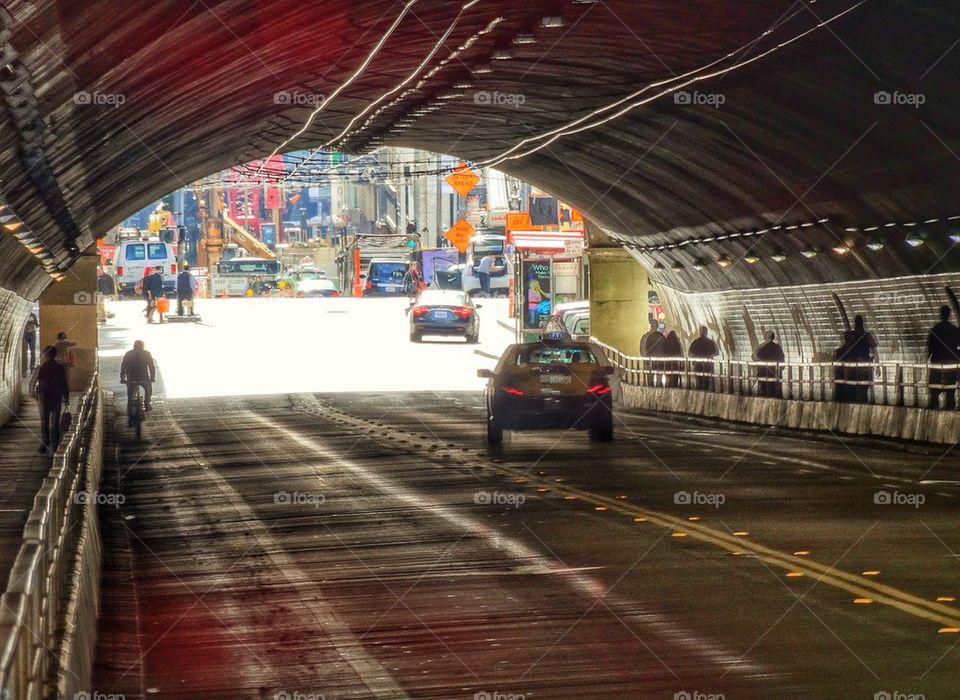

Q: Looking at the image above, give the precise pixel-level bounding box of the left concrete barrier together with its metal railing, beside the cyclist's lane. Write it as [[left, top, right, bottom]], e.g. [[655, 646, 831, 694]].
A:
[[0, 373, 103, 700]]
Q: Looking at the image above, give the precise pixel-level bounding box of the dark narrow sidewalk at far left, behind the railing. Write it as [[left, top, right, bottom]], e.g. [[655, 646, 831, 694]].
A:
[[0, 398, 51, 590]]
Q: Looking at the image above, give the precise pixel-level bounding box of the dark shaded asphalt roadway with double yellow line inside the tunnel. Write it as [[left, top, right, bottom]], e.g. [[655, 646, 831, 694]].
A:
[[96, 298, 960, 699]]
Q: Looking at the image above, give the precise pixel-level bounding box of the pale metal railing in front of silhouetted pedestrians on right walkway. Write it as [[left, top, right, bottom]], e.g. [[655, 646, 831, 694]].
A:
[[591, 338, 960, 408]]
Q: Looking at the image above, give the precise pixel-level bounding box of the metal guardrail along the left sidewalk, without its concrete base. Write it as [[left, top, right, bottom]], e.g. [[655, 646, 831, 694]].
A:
[[0, 373, 102, 700]]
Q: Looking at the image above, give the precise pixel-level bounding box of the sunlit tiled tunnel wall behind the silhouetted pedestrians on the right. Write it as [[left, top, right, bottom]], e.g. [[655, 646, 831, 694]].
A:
[[656, 273, 960, 363]]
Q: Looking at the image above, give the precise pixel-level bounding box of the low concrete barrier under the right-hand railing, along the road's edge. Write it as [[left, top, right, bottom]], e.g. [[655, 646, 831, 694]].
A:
[[622, 383, 960, 445]]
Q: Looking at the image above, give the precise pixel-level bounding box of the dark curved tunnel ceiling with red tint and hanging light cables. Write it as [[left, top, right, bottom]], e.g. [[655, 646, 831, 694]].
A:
[[0, 0, 960, 296]]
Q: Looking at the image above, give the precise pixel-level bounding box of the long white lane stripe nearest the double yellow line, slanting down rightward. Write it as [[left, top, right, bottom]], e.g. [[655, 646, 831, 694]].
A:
[[249, 408, 771, 675]]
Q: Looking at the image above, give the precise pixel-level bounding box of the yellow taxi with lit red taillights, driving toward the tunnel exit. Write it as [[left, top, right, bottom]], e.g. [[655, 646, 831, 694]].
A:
[[477, 332, 616, 444]]
